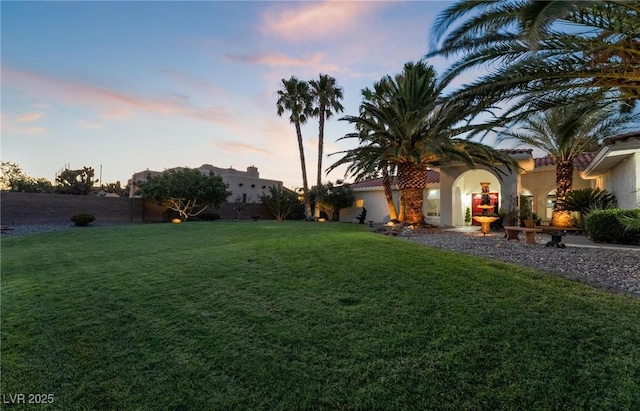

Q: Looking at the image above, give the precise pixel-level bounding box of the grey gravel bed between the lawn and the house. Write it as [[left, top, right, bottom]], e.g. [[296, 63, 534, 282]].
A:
[[401, 230, 640, 298]]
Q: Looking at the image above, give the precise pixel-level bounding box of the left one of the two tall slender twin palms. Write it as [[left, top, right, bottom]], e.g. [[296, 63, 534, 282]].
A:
[[276, 76, 311, 218]]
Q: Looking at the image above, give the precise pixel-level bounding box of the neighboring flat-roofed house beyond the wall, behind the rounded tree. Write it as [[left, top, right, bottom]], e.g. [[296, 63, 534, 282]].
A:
[[129, 164, 282, 203]]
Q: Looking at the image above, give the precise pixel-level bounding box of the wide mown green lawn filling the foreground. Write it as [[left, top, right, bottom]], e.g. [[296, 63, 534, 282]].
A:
[[0, 221, 640, 410]]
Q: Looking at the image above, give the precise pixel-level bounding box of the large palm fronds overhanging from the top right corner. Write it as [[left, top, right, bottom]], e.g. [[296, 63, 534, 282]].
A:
[[428, 0, 640, 128]]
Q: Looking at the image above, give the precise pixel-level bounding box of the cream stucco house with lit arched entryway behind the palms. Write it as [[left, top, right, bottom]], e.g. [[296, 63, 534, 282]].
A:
[[340, 131, 640, 227]]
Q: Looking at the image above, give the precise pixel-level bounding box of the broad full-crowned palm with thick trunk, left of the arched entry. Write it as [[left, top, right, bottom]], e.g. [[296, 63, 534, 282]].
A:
[[330, 61, 513, 225]]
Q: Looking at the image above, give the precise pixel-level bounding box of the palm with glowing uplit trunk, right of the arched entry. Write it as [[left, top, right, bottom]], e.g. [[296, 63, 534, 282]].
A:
[[498, 103, 640, 227]]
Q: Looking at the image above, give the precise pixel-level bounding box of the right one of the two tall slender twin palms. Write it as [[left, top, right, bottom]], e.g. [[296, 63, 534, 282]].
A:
[[309, 74, 344, 187]]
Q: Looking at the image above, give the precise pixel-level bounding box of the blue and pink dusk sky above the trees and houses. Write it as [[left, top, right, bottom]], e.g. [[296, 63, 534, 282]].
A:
[[1, 1, 476, 188]]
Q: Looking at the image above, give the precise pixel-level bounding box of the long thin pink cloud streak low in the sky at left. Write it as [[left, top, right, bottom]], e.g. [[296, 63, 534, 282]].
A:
[[2, 66, 238, 125]]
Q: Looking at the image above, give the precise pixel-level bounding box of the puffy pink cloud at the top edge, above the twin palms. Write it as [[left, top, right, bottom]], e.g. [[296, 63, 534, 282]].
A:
[[261, 0, 386, 41]]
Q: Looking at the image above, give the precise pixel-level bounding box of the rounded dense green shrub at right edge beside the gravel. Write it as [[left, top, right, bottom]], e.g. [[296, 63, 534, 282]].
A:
[[584, 209, 640, 245]]
